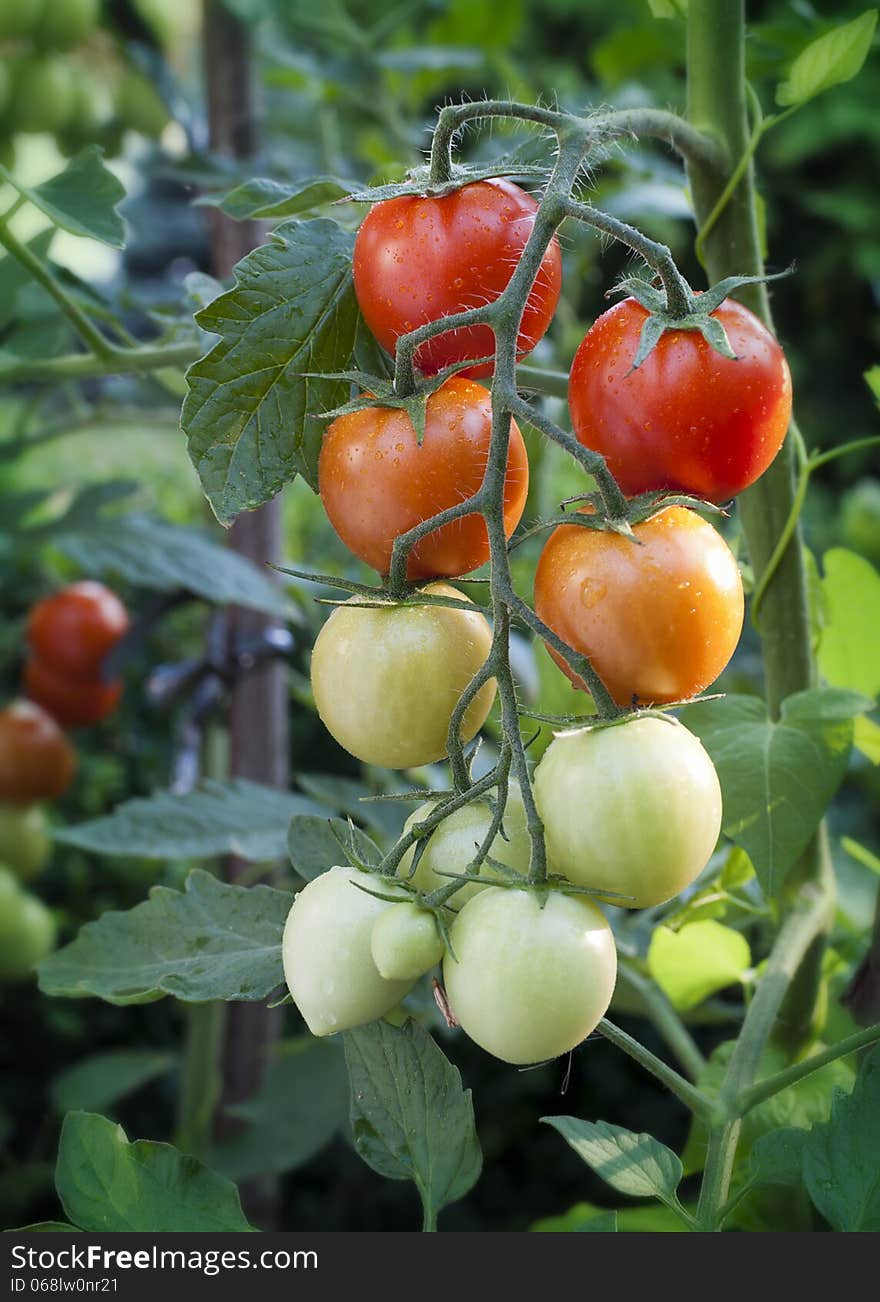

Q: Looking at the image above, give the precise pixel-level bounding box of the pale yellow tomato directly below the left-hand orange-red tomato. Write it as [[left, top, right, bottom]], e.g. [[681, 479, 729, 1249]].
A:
[[311, 583, 496, 768]]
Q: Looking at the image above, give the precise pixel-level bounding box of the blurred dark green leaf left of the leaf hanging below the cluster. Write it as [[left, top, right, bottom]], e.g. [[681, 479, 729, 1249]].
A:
[[211, 1035, 349, 1180]]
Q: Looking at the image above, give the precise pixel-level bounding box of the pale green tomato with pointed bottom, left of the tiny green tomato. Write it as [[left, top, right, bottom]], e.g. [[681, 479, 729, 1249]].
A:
[[281, 867, 413, 1035]]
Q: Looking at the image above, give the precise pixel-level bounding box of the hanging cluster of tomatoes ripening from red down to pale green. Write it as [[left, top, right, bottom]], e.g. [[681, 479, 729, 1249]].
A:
[[291, 181, 790, 1064]]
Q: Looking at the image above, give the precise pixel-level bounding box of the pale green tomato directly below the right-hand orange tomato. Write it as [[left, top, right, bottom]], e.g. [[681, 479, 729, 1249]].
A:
[[535, 716, 721, 909]]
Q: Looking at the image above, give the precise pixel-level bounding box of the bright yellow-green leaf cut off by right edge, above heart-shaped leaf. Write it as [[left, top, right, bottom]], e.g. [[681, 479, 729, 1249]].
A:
[[819, 547, 880, 697]]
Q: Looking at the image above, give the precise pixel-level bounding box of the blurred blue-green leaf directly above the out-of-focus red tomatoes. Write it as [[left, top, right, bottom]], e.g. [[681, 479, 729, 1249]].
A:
[[53, 514, 294, 620]]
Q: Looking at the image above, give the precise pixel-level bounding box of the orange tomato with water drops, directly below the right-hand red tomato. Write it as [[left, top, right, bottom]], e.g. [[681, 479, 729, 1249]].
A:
[[535, 506, 743, 706]]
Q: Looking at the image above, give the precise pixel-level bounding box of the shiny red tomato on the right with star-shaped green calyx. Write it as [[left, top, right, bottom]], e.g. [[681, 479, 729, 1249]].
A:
[[569, 298, 791, 501]]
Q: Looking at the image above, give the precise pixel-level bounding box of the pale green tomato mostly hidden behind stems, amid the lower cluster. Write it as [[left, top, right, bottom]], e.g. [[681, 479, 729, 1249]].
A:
[[397, 781, 531, 909]]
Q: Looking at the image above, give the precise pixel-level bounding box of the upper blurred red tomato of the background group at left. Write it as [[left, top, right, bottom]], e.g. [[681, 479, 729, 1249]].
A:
[[27, 579, 129, 678]]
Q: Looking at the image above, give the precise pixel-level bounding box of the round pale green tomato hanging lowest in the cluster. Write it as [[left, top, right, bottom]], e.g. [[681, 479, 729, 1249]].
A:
[[443, 887, 617, 1064]]
